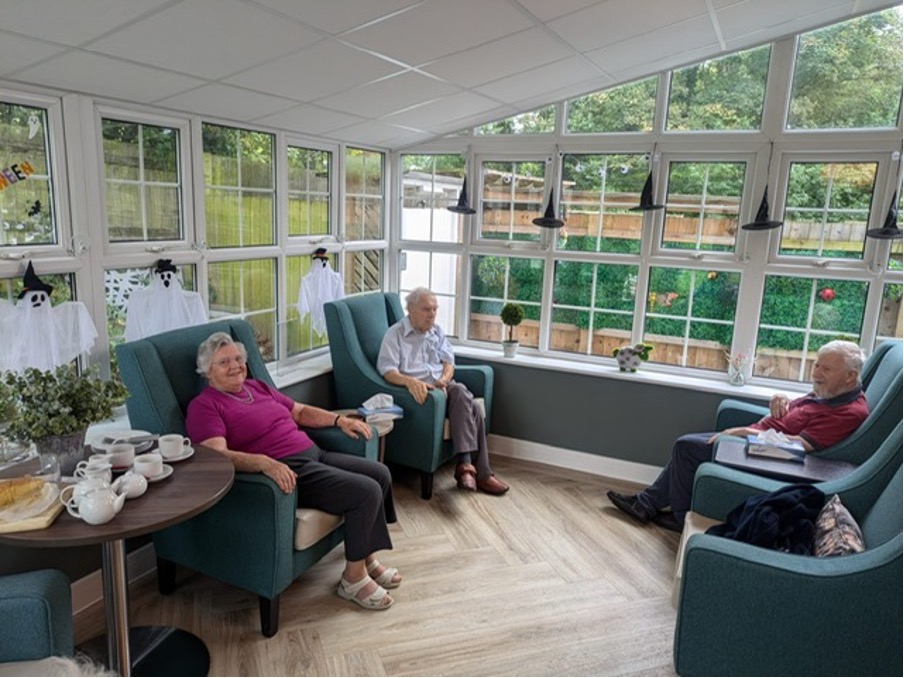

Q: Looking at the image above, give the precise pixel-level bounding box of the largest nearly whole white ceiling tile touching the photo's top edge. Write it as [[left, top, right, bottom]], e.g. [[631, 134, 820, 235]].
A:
[[90, 0, 322, 78]]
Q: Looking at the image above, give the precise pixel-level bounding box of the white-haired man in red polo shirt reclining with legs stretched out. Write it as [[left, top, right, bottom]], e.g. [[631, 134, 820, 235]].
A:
[[607, 341, 869, 532]]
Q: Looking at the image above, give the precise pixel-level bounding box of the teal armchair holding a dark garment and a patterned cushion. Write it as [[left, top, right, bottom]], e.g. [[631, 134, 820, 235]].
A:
[[673, 422, 902, 676]]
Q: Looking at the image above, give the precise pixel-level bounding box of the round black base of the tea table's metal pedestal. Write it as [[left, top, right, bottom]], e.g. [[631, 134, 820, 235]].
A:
[[77, 626, 210, 676]]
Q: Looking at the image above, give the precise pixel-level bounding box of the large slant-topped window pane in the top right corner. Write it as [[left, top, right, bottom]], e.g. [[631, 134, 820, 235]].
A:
[[788, 7, 902, 129]]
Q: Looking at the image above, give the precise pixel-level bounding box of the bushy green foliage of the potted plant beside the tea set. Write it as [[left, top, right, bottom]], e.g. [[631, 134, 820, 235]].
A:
[[0, 365, 128, 442]]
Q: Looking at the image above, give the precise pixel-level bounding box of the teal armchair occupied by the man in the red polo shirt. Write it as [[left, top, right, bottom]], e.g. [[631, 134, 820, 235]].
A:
[[715, 340, 904, 464]]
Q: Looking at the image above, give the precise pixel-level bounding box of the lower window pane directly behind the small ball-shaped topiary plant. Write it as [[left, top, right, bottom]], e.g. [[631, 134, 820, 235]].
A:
[[468, 255, 543, 348]]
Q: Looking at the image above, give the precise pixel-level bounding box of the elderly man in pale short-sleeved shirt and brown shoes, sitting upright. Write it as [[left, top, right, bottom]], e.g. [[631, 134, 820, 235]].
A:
[[377, 287, 509, 495]]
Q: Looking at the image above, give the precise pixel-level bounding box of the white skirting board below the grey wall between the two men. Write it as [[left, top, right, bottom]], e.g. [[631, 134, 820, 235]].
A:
[[487, 434, 662, 485]]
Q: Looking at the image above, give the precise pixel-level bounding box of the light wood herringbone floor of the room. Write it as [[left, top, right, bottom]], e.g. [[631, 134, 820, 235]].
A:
[[76, 458, 678, 676]]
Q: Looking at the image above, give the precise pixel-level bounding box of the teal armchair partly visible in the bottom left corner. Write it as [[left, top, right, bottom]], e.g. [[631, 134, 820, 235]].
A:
[[0, 570, 73, 672]]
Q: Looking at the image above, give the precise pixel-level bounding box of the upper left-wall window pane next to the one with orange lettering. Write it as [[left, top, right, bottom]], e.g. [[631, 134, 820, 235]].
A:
[[101, 119, 182, 242]]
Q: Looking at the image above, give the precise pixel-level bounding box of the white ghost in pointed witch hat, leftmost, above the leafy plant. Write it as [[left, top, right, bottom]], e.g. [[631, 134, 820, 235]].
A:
[[0, 262, 97, 372]]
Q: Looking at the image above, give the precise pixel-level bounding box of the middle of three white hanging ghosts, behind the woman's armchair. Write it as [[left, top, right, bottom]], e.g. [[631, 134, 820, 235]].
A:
[[125, 259, 207, 341]]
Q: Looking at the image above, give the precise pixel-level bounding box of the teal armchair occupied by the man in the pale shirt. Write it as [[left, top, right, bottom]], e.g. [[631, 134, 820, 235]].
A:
[[324, 292, 493, 499]]
